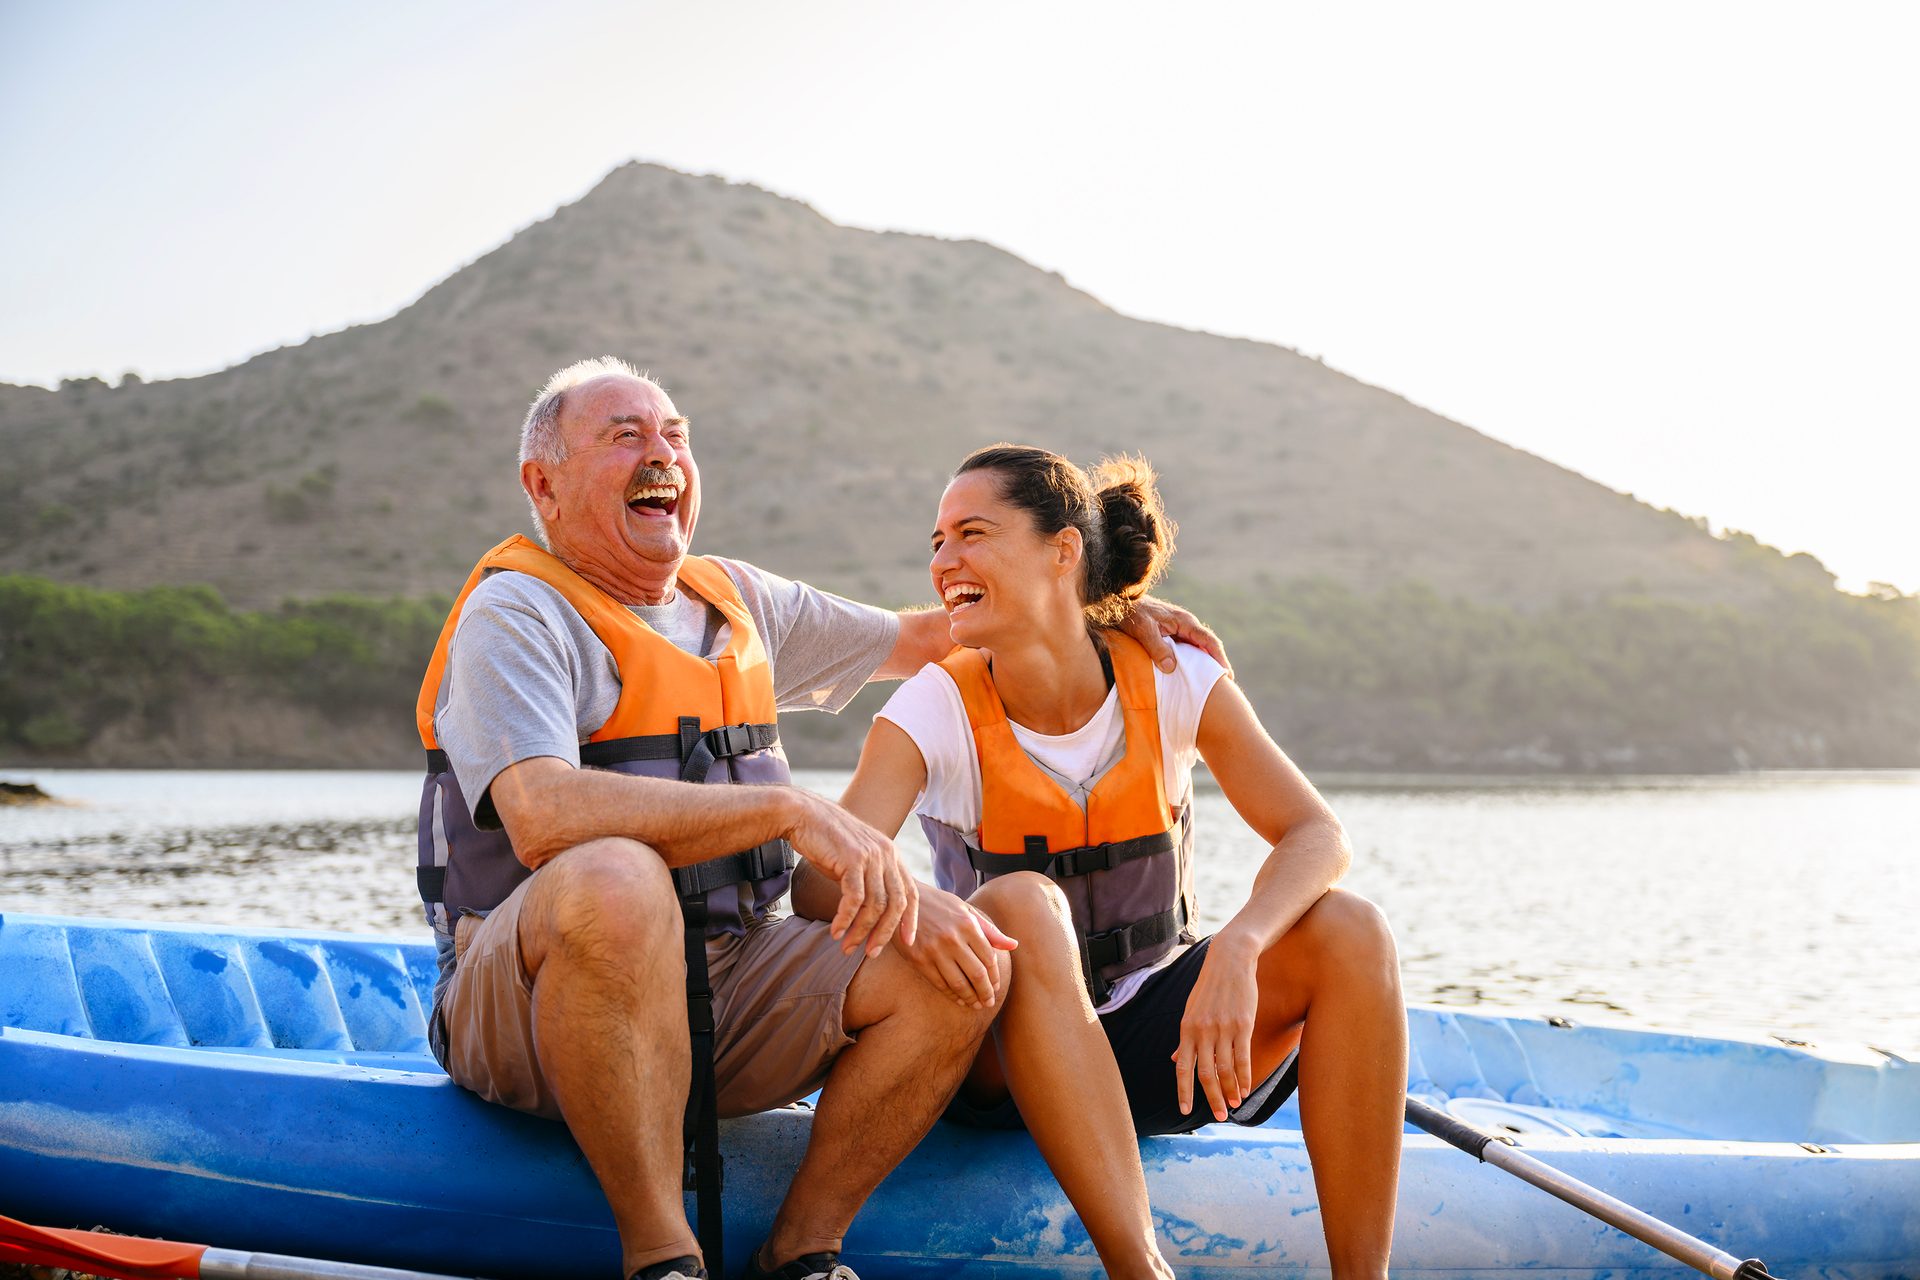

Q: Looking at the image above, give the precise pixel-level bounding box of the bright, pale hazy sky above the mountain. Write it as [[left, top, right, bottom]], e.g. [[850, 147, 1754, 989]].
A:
[[0, 0, 1920, 591]]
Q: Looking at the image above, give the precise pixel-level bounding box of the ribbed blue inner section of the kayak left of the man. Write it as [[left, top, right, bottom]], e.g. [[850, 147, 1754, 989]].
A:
[[0, 915, 430, 1054]]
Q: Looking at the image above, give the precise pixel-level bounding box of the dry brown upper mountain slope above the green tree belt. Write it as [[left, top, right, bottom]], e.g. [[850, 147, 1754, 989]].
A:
[[0, 163, 1832, 610]]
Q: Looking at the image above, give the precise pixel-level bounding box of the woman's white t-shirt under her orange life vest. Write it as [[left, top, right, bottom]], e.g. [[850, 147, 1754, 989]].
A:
[[876, 645, 1225, 1013]]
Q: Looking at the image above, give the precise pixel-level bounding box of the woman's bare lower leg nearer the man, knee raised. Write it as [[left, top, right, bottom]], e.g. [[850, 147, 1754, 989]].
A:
[[964, 871, 1173, 1280]]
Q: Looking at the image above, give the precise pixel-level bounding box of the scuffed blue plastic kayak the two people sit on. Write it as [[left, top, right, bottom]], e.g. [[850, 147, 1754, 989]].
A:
[[0, 913, 1920, 1280]]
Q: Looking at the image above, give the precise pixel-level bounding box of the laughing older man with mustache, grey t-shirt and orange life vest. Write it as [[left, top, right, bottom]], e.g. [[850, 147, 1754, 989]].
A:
[[419, 359, 1210, 1280]]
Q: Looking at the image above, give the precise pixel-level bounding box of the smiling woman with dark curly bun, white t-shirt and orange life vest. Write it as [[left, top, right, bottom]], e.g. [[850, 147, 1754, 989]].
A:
[[843, 445, 1407, 1276]]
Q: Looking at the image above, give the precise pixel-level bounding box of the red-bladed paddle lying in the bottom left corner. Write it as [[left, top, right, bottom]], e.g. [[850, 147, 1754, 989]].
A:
[[0, 1215, 476, 1280]]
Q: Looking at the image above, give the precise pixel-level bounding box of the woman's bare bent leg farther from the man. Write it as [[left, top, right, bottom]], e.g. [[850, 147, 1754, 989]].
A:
[[1254, 889, 1407, 1280]]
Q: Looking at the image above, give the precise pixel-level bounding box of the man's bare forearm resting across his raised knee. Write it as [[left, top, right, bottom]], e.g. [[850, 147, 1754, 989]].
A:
[[492, 756, 804, 867]]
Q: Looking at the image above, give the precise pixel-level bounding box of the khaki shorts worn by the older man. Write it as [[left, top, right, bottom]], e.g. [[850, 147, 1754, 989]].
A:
[[440, 881, 866, 1121]]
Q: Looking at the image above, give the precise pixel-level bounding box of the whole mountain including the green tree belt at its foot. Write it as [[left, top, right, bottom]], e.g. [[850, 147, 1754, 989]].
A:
[[0, 165, 1920, 770]]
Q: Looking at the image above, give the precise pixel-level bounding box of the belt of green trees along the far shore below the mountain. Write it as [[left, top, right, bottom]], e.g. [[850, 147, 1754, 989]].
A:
[[0, 578, 1920, 771]]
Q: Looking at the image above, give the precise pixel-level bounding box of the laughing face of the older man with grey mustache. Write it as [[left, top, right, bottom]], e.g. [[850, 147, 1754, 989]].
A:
[[526, 374, 701, 576]]
